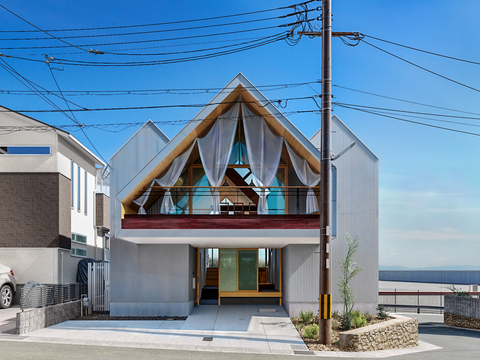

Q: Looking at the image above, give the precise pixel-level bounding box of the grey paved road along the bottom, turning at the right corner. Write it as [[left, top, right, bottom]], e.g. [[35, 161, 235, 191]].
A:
[[0, 315, 480, 360]]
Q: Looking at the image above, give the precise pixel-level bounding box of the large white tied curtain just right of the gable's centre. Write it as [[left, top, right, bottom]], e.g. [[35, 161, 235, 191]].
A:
[[242, 103, 283, 214]]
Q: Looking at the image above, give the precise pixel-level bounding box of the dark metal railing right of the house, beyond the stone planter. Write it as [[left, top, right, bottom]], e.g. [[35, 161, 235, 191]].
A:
[[378, 290, 480, 314]]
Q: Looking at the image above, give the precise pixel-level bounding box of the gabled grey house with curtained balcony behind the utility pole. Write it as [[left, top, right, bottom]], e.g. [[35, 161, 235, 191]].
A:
[[110, 74, 378, 316]]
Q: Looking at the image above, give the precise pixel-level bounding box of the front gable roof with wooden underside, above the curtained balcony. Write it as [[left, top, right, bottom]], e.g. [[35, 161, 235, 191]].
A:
[[115, 73, 320, 208]]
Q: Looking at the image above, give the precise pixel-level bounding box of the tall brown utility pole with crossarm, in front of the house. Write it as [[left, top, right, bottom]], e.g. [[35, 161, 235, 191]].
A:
[[298, 0, 354, 345]]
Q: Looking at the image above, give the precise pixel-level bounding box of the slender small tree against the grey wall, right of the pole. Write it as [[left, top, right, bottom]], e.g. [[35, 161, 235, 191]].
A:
[[337, 233, 363, 330]]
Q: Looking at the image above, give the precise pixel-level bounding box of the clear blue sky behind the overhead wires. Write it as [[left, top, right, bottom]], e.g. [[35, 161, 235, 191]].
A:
[[0, 0, 480, 268]]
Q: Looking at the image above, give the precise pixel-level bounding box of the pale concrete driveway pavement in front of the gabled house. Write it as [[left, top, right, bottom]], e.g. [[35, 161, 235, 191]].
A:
[[0, 305, 458, 358]]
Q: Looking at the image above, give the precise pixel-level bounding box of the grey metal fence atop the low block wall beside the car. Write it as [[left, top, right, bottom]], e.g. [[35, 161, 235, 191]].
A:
[[20, 283, 88, 311]]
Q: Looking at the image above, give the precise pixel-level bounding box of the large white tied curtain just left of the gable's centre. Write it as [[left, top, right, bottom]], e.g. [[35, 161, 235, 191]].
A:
[[197, 102, 240, 214]]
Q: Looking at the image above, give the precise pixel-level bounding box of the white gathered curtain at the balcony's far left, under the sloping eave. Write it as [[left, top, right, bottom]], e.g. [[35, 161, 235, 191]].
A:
[[134, 141, 196, 215]]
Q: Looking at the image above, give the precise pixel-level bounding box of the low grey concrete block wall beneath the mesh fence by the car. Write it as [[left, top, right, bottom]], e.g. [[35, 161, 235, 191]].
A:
[[17, 300, 82, 335]]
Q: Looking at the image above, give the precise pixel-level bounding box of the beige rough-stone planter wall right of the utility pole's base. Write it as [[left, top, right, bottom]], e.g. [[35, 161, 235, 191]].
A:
[[340, 315, 418, 351]]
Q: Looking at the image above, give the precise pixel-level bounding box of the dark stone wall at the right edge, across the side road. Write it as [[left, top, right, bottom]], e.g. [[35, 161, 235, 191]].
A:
[[443, 295, 480, 329]]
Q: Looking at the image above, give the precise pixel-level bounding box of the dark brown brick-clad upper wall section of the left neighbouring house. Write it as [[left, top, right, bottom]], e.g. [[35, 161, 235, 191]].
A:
[[0, 173, 71, 249]]
